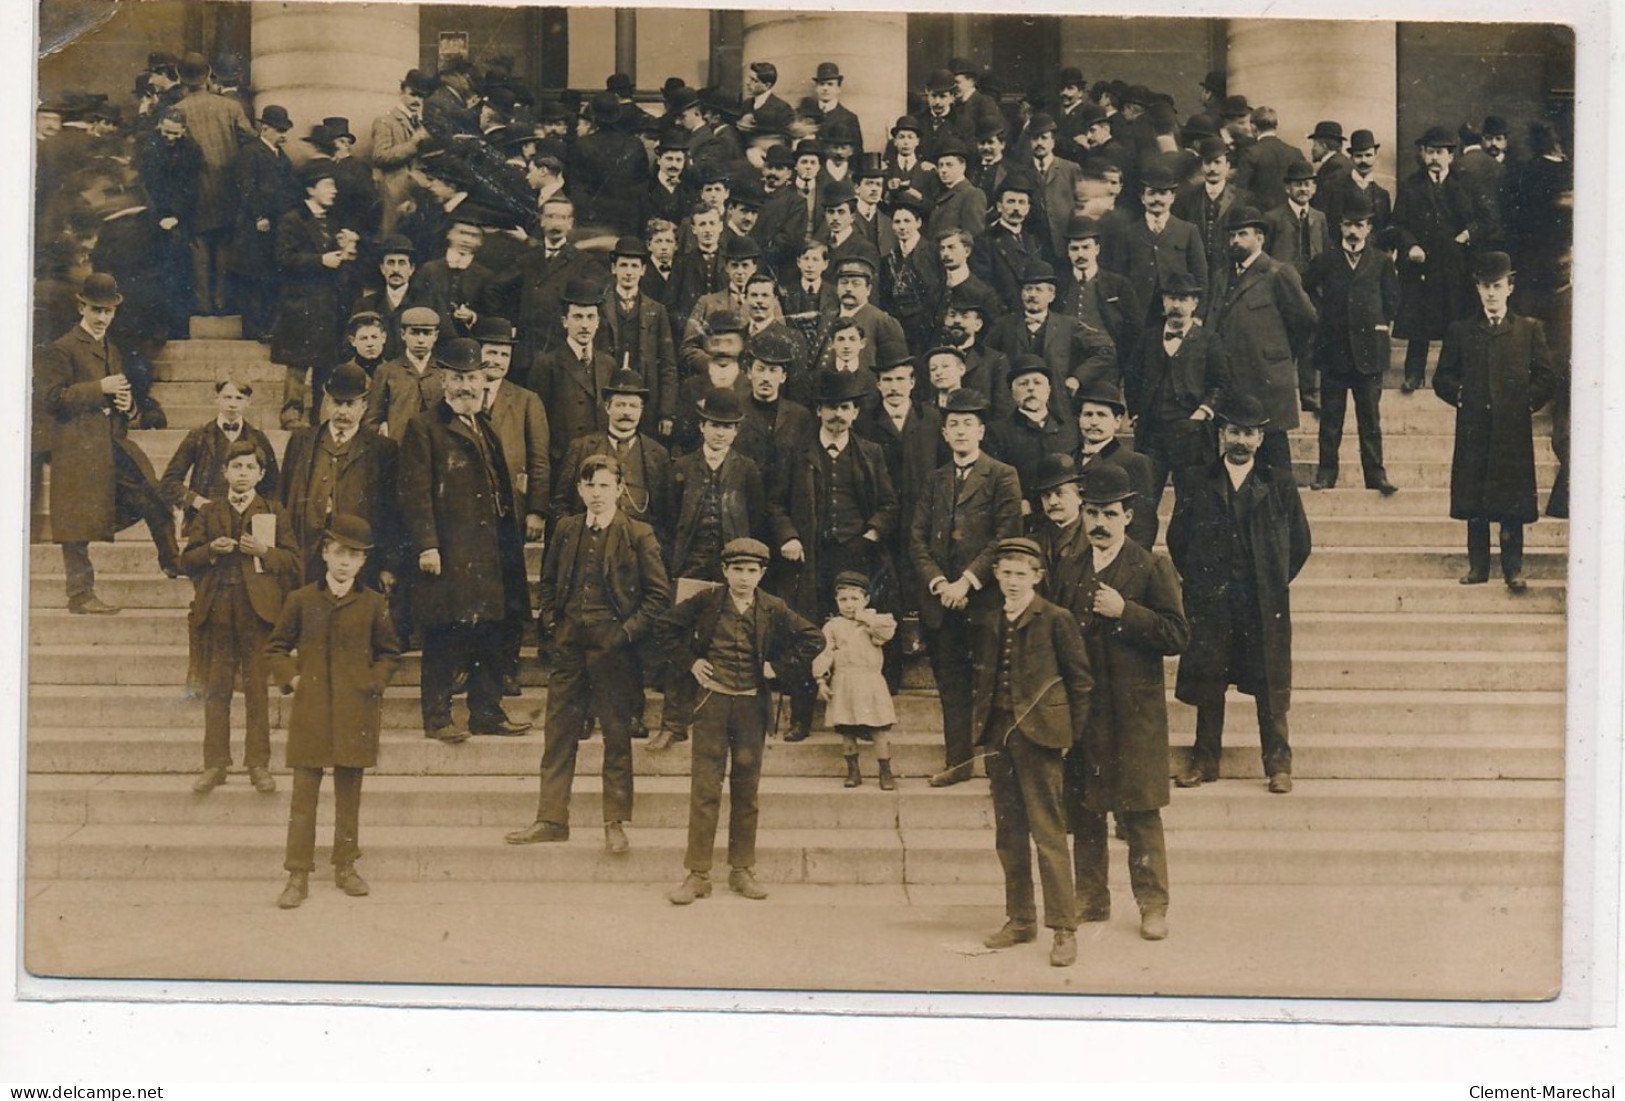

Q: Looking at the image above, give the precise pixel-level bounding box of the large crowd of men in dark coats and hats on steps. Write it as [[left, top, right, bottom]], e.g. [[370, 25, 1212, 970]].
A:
[[34, 54, 1571, 963]]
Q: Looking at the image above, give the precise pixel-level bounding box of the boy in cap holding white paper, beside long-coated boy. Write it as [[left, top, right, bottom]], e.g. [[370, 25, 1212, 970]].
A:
[[180, 438, 299, 796]]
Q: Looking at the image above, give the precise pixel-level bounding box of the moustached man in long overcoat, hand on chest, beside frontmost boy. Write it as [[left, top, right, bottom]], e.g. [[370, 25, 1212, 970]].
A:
[[1038, 463, 1190, 940]]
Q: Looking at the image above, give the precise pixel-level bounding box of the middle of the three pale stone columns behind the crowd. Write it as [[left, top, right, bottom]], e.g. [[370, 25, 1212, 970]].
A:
[[744, 11, 908, 149]]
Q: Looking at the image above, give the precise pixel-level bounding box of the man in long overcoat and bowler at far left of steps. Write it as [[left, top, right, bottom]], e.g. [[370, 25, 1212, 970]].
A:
[[34, 273, 180, 615]]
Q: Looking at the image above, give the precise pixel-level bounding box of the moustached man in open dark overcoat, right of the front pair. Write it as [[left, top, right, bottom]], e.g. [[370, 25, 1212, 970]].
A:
[[1168, 393, 1310, 794]]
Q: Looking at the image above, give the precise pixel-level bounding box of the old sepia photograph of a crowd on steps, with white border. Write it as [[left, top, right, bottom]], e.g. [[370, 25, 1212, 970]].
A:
[[13, 0, 1619, 1023]]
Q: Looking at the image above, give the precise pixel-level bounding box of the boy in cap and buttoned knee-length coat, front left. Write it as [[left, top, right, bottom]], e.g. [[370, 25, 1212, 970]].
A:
[[265, 515, 401, 909]]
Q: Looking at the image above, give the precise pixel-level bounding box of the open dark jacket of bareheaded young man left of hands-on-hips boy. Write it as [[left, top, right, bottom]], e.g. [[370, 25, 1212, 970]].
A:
[[538, 510, 671, 643]]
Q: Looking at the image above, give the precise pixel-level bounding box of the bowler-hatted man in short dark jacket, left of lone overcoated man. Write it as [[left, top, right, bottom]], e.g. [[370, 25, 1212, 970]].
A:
[[1303, 195, 1399, 497]]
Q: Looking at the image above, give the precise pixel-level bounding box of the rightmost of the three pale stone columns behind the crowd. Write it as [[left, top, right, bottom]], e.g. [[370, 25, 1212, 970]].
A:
[[1229, 19, 1411, 193]]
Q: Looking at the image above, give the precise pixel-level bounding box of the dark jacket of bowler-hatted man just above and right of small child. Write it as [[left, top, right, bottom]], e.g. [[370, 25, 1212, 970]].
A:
[[908, 455, 1021, 627]]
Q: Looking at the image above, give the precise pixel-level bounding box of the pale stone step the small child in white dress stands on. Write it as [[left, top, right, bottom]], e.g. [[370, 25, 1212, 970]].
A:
[[28, 776, 1563, 831]]
